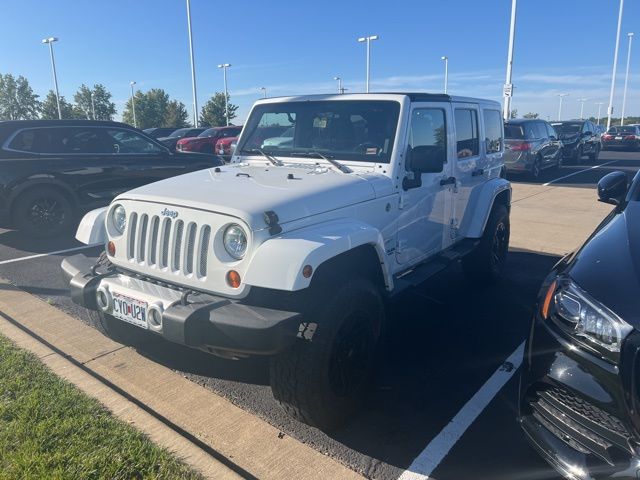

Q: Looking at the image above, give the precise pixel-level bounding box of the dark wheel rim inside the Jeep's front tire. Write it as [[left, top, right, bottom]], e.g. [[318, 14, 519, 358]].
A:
[[329, 312, 373, 397]]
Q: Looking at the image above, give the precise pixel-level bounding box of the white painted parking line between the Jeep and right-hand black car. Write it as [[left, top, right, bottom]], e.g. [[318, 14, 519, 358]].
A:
[[398, 342, 524, 480]]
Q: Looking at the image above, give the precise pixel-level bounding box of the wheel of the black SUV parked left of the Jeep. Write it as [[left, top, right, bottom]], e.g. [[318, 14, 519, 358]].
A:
[[13, 187, 74, 237]]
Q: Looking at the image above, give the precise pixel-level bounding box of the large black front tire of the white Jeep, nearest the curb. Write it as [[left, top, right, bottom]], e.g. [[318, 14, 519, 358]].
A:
[[270, 278, 384, 431]]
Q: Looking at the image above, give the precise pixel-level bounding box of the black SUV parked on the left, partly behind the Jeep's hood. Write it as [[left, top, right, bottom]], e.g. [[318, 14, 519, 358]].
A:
[[0, 120, 222, 236]]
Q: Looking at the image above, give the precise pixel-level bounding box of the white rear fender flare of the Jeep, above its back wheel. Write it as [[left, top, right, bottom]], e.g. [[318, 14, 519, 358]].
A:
[[460, 178, 511, 238]]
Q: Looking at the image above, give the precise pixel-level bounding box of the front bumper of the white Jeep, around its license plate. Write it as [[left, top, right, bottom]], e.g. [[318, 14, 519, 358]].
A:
[[62, 255, 301, 356]]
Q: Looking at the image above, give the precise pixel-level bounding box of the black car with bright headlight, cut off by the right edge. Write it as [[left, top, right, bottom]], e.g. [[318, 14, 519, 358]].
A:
[[520, 168, 640, 479]]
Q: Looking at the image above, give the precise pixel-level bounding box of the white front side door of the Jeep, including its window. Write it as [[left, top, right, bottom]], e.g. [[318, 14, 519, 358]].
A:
[[396, 102, 455, 265]]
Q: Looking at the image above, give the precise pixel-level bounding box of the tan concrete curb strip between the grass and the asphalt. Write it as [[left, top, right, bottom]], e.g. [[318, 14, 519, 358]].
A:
[[0, 279, 362, 480]]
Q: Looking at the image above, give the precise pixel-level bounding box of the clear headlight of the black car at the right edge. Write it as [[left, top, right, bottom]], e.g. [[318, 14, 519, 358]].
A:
[[545, 279, 633, 362]]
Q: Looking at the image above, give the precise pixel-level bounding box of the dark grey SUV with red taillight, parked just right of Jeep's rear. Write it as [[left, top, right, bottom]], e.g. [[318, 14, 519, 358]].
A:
[[504, 119, 562, 178]]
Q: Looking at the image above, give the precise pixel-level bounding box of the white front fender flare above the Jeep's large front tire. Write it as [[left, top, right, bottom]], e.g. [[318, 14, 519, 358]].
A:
[[245, 219, 393, 291]]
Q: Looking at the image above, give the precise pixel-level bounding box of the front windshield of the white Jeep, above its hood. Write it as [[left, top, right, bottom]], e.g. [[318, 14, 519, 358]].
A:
[[238, 100, 400, 163]]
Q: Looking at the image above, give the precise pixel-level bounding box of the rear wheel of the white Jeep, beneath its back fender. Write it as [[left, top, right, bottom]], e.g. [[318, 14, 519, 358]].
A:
[[462, 205, 510, 283]]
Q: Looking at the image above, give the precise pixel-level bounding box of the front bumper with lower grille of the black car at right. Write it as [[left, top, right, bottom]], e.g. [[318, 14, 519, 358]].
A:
[[519, 315, 640, 480]]
